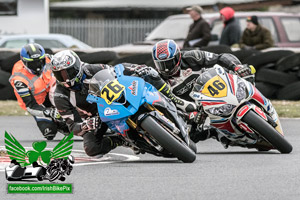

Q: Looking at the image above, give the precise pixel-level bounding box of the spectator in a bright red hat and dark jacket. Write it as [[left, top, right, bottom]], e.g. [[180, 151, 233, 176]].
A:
[[220, 7, 241, 46]]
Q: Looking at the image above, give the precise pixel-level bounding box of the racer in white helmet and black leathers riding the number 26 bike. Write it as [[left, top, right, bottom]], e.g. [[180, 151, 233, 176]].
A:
[[51, 50, 123, 156]]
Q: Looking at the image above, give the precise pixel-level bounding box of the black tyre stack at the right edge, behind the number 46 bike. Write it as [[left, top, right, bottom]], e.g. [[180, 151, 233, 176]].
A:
[[239, 50, 300, 100]]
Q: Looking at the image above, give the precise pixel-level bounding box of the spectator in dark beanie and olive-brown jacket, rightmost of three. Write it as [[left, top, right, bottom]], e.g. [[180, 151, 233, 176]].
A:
[[240, 15, 274, 50]]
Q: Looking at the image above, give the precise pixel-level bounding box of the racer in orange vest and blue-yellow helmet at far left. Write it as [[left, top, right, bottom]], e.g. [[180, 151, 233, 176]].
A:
[[9, 43, 68, 140]]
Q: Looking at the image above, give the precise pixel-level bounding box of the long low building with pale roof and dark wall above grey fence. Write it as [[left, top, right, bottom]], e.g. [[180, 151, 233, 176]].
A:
[[50, 0, 299, 19]]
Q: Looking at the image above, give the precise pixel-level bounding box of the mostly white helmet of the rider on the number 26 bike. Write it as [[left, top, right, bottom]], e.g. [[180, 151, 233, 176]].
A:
[[51, 50, 83, 87]]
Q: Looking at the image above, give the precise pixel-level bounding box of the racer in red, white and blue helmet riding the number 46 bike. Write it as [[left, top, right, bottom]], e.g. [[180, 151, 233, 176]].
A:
[[135, 40, 255, 145]]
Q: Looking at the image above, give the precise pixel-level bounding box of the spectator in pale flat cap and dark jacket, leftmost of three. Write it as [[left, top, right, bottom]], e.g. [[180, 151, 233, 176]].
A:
[[183, 6, 210, 47]]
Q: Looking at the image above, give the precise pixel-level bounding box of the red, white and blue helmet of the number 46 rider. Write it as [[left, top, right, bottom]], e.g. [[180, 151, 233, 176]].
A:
[[152, 40, 181, 77]]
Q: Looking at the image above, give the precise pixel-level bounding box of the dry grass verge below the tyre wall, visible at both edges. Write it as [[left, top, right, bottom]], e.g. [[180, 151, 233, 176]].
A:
[[0, 100, 300, 118]]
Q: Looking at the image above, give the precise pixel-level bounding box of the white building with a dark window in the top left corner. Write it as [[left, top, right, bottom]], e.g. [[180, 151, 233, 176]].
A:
[[0, 0, 49, 34]]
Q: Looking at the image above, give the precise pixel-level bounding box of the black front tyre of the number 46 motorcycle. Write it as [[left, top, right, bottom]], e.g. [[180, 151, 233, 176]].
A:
[[242, 110, 293, 153]]
